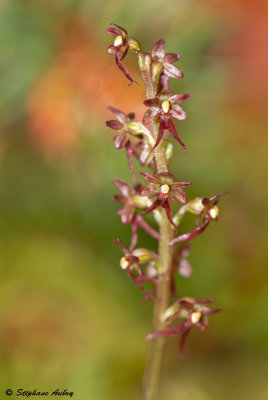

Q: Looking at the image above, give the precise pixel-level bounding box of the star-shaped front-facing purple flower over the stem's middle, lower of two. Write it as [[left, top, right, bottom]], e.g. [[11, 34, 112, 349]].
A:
[[140, 172, 193, 230]]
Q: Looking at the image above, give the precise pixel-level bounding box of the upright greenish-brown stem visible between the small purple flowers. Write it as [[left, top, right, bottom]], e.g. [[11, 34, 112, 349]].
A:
[[141, 68, 173, 400]]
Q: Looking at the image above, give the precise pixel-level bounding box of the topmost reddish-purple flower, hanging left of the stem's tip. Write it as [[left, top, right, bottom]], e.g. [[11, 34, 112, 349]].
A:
[[106, 23, 139, 84]]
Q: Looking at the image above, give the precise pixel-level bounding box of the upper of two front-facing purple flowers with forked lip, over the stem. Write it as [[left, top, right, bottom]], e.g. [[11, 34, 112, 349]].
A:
[[143, 94, 190, 153]]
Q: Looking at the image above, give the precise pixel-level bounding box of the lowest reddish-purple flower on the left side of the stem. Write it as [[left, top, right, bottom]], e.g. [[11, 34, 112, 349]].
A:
[[113, 238, 158, 300]]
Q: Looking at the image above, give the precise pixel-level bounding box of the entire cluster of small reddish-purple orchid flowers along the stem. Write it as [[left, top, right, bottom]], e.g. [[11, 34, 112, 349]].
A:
[[106, 24, 227, 354]]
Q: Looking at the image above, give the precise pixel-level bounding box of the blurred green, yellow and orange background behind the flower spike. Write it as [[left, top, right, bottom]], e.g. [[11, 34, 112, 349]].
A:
[[0, 0, 268, 400]]
